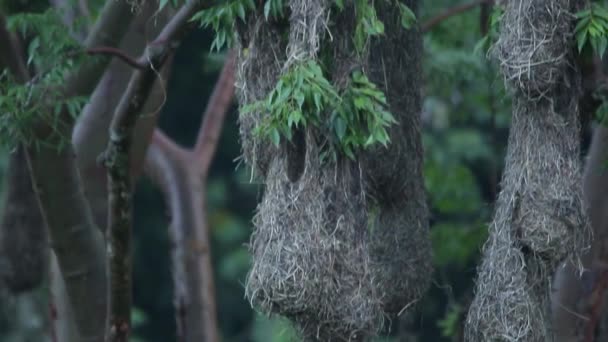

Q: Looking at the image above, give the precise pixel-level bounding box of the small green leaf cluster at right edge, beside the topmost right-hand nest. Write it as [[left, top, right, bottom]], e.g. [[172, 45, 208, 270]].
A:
[[574, 3, 608, 58]]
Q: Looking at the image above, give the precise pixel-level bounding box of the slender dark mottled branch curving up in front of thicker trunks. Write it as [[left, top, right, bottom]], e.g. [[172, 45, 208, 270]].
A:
[[103, 1, 216, 342]]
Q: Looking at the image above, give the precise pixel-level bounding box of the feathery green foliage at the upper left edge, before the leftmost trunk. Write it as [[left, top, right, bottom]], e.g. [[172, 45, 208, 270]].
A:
[[0, 9, 90, 148]]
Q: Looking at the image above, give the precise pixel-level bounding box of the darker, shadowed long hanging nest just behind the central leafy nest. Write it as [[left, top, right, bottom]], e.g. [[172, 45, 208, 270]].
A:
[[362, 1, 433, 314]]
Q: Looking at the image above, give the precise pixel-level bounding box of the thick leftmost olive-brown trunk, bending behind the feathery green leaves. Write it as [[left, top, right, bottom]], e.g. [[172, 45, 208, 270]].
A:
[[22, 1, 137, 342]]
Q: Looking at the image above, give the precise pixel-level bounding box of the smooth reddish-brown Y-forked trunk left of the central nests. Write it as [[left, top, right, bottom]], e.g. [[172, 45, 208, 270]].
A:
[[145, 51, 235, 342]]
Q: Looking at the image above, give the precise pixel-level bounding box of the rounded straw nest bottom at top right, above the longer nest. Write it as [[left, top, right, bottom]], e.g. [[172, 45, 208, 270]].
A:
[[493, 0, 573, 99]]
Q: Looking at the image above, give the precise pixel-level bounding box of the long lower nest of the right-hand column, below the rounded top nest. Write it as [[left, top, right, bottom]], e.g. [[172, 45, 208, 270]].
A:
[[467, 88, 590, 341]]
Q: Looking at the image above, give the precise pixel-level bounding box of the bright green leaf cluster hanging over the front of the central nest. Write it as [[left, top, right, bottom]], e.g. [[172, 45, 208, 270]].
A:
[[241, 60, 396, 160]]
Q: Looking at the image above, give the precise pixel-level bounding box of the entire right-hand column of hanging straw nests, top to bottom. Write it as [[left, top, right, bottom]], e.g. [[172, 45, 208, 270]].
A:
[[465, 1, 591, 342]]
